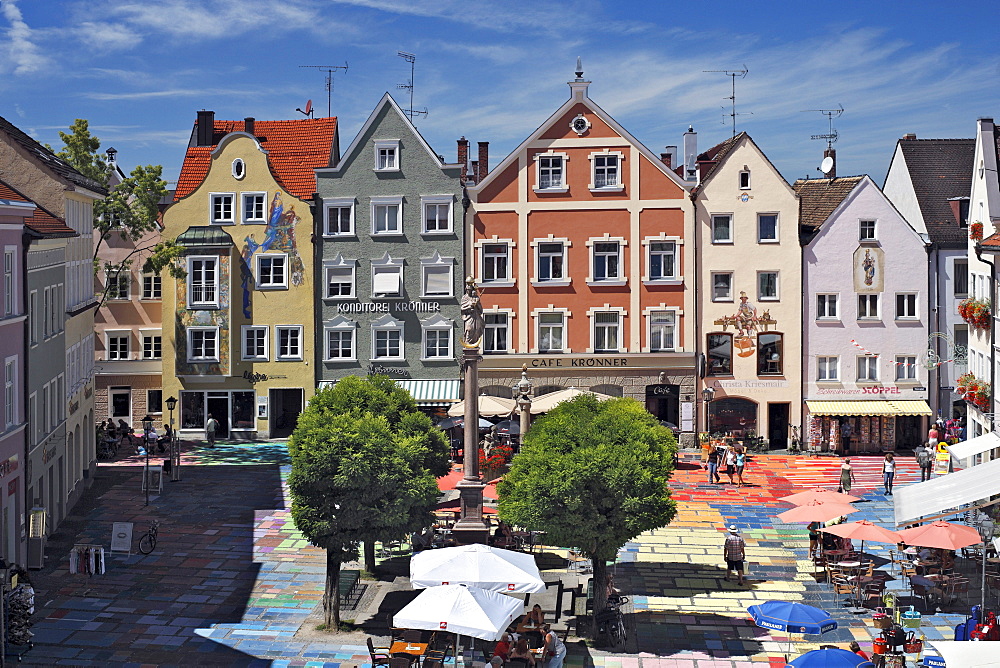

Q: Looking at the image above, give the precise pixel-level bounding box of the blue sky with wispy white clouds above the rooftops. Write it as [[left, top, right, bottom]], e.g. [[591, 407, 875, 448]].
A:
[[0, 0, 1000, 184]]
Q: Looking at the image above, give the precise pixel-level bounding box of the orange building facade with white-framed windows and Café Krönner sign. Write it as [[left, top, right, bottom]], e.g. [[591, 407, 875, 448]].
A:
[[466, 73, 697, 440]]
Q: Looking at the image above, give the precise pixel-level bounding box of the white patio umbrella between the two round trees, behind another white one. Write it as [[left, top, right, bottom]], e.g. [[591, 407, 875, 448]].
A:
[[410, 543, 545, 594]]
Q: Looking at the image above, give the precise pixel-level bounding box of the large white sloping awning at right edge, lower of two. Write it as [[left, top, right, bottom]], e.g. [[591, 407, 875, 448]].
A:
[[893, 459, 1000, 526]]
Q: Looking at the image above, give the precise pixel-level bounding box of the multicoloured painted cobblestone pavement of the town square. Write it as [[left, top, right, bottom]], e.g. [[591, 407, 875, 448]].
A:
[[24, 444, 964, 668]]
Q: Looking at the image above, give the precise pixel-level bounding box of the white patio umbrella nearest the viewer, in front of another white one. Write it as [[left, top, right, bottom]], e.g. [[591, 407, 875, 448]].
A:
[[392, 585, 524, 640]]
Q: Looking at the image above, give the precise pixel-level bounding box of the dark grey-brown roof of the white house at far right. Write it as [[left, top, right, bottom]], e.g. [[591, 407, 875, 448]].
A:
[[899, 139, 976, 246]]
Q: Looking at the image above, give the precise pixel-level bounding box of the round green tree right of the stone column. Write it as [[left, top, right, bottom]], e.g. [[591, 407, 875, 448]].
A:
[[497, 394, 677, 632]]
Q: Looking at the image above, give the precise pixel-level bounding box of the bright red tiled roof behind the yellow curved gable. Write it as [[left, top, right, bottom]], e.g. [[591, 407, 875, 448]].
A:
[[174, 117, 337, 201]]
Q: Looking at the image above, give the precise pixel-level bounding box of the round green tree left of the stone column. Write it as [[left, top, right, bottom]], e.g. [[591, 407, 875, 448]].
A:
[[288, 376, 449, 630]]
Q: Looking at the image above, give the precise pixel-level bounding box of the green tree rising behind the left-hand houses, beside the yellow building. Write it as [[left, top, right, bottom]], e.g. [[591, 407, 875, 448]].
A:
[[48, 118, 184, 305]]
